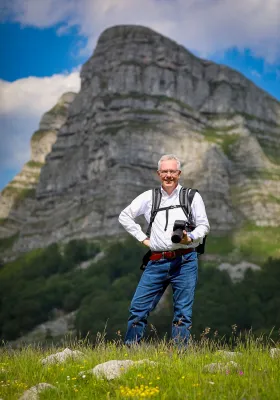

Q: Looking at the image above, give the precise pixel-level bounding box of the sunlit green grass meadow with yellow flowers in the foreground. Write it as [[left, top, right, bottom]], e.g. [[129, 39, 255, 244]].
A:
[[0, 338, 280, 400]]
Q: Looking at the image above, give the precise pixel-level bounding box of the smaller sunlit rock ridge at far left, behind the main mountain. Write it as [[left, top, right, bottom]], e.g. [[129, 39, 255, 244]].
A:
[[0, 92, 76, 238]]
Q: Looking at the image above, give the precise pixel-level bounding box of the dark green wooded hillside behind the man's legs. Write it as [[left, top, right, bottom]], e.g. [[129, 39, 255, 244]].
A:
[[0, 238, 280, 341]]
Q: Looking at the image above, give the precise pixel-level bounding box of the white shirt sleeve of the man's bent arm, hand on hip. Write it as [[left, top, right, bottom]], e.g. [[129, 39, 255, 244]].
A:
[[119, 190, 152, 242]]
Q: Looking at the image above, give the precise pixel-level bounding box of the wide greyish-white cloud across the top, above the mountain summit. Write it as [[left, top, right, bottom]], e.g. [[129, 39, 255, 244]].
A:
[[3, 0, 280, 62]]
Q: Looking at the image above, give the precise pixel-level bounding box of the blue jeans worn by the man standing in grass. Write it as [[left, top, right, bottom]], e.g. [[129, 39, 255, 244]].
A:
[[125, 251, 198, 345]]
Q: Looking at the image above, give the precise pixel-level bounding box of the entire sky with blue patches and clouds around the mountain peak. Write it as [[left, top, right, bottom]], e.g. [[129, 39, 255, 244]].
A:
[[0, 0, 280, 190]]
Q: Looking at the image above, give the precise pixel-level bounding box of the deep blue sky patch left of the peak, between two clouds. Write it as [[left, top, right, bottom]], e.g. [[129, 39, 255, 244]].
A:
[[0, 22, 87, 82]]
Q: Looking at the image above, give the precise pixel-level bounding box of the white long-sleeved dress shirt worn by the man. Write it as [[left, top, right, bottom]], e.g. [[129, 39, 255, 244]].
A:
[[119, 184, 210, 251]]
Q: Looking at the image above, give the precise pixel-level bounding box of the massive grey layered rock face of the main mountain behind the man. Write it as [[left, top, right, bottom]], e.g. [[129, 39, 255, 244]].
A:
[[0, 26, 280, 252]]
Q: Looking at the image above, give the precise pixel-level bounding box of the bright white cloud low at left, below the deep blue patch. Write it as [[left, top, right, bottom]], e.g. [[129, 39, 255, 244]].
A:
[[0, 71, 80, 174]]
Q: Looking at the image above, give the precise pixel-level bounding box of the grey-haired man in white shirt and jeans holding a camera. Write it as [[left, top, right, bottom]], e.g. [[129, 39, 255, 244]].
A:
[[119, 154, 210, 345]]
